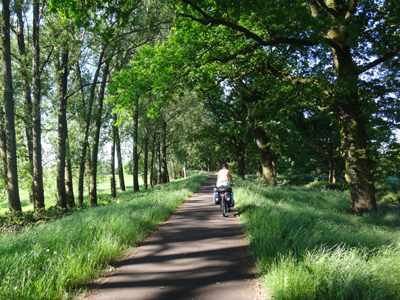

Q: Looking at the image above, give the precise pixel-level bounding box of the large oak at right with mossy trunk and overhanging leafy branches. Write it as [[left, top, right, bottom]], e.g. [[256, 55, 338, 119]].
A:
[[162, 0, 400, 215]]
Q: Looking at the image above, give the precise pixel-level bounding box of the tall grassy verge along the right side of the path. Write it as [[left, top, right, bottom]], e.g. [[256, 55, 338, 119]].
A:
[[235, 180, 400, 299]]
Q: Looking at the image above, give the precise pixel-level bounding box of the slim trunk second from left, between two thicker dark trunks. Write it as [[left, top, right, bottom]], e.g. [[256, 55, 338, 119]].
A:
[[15, 0, 34, 203]]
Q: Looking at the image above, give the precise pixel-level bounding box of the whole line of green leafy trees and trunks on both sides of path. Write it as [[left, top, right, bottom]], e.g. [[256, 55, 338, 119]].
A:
[[0, 0, 400, 215]]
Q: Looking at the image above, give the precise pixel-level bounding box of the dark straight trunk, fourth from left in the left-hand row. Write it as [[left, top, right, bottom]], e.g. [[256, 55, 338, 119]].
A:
[[57, 49, 69, 209]]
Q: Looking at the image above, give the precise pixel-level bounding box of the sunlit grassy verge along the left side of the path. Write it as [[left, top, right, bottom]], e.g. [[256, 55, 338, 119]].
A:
[[0, 173, 208, 299]]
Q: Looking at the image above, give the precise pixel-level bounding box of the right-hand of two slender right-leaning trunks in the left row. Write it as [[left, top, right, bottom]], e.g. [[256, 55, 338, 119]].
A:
[[89, 60, 110, 205]]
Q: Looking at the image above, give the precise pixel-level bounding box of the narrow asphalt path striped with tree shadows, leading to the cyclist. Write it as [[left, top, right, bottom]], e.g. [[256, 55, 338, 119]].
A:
[[88, 175, 260, 300]]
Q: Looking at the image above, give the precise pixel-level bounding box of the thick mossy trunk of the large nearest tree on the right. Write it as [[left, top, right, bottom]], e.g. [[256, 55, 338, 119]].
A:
[[326, 10, 377, 215]]
